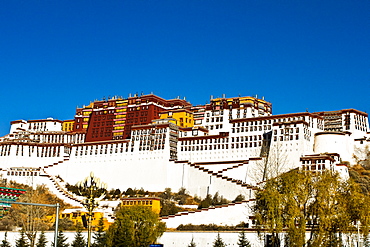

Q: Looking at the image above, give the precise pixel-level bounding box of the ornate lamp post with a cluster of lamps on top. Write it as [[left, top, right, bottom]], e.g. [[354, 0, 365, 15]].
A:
[[77, 172, 107, 247]]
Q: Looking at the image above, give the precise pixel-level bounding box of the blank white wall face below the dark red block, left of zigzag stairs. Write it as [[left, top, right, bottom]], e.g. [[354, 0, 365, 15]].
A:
[[46, 148, 172, 191]]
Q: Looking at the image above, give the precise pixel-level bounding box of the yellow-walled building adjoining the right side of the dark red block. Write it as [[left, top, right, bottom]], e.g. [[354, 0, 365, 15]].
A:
[[159, 109, 194, 128]]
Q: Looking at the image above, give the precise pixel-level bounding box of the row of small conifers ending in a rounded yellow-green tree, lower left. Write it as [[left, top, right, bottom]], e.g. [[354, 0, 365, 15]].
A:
[[0, 206, 166, 247]]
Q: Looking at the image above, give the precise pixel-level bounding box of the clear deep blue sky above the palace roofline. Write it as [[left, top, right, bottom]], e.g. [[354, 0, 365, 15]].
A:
[[0, 0, 370, 136]]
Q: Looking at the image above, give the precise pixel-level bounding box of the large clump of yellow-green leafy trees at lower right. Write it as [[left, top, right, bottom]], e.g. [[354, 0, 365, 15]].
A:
[[253, 169, 370, 247]]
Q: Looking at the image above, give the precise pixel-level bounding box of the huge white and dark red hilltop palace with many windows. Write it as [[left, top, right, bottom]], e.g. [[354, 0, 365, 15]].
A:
[[0, 94, 370, 227]]
